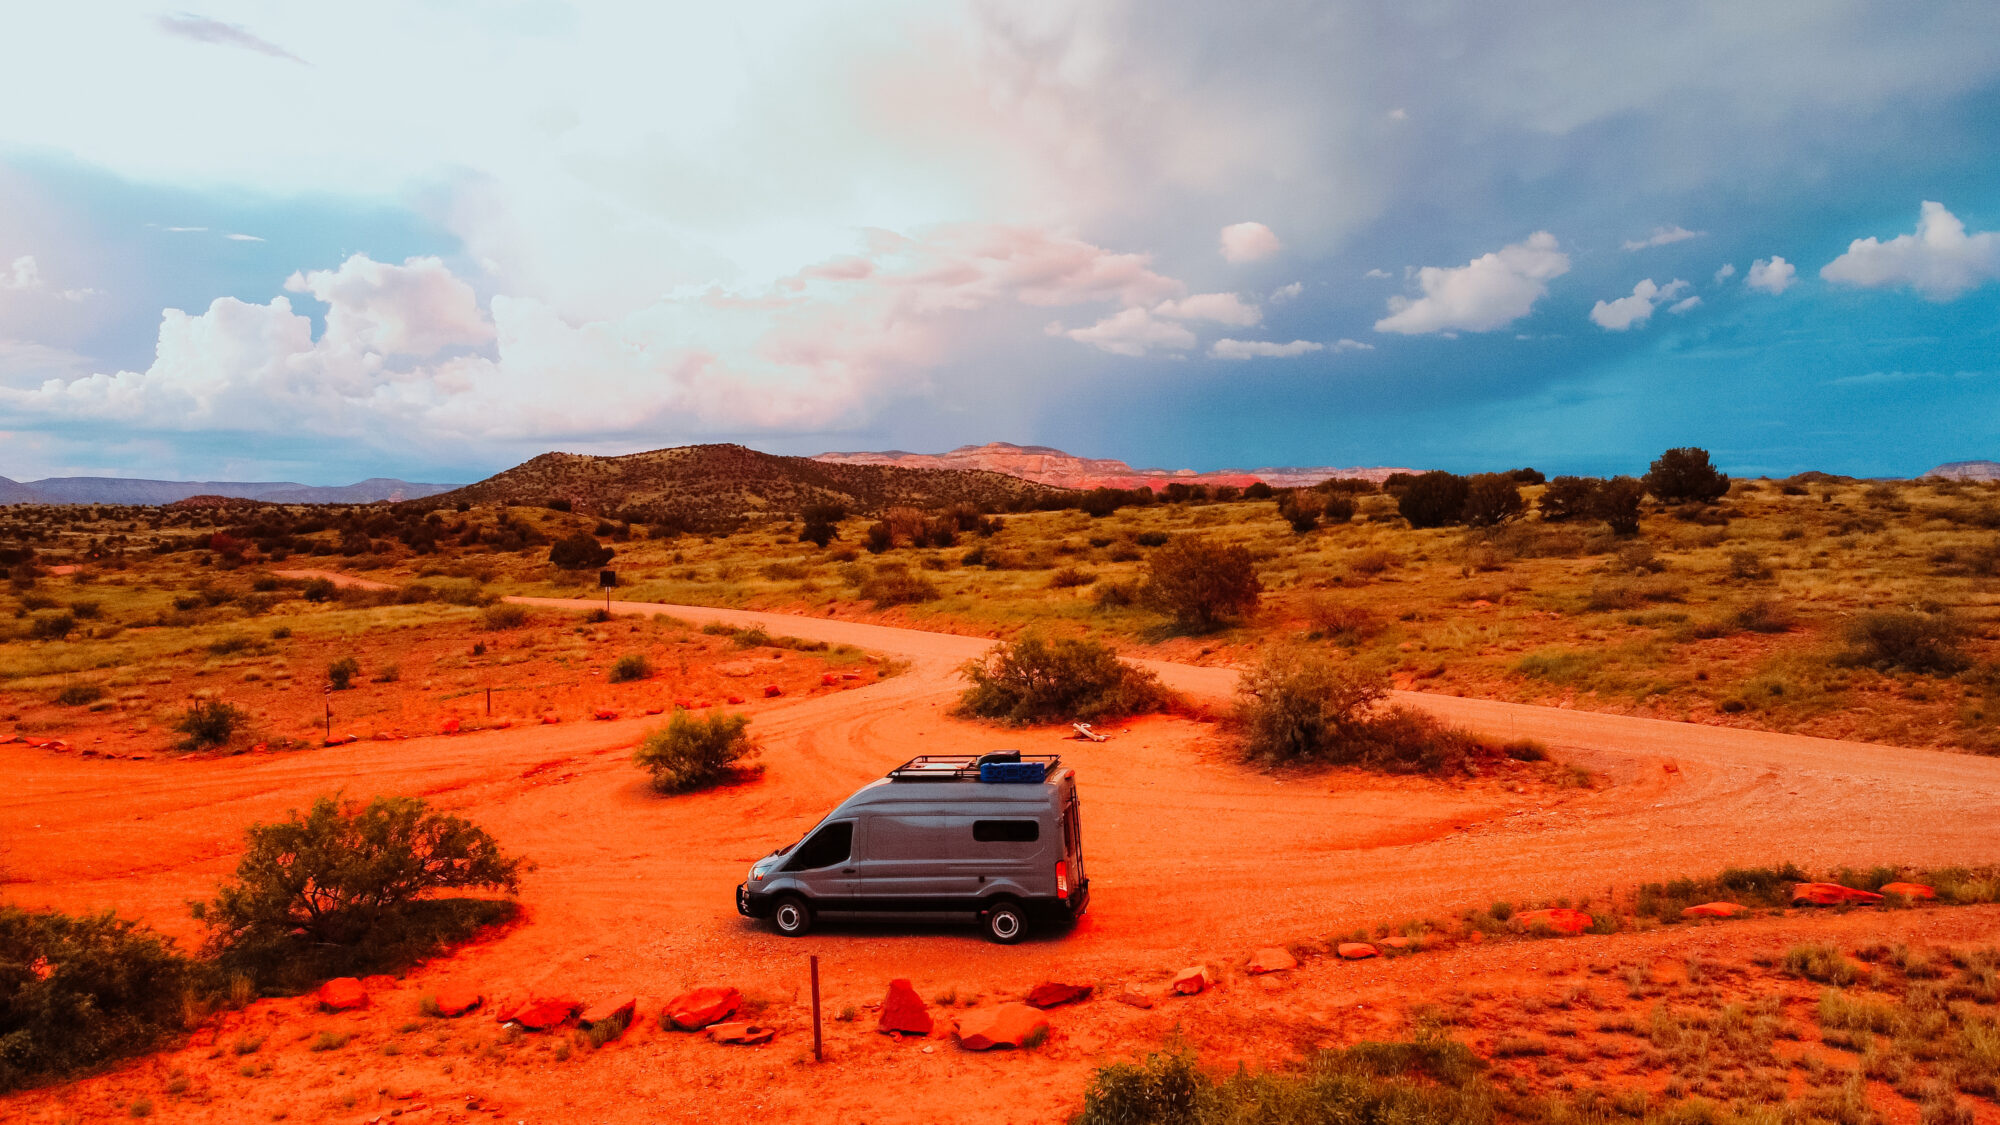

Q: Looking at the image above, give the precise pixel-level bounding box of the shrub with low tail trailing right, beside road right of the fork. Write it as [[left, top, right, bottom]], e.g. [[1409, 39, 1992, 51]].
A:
[[1236, 649, 1500, 773]]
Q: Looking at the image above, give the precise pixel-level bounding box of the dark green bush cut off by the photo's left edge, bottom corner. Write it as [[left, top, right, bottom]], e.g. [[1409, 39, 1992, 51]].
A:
[[0, 905, 202, 1093]]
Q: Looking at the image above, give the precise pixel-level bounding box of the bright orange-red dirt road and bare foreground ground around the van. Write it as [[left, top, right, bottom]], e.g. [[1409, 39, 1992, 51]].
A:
[[0, 603, 2000, 1125]]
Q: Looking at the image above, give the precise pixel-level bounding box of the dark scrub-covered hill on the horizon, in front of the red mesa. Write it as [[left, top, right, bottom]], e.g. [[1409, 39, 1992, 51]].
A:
[[424, 444, 1062, 528]]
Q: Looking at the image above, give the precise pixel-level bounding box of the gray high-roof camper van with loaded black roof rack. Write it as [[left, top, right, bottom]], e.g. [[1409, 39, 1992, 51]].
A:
[[736, 751, 1090, 945]]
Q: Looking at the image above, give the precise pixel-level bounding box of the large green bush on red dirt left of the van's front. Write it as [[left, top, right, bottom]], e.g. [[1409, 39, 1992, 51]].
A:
[[194, 797, 522, 991]]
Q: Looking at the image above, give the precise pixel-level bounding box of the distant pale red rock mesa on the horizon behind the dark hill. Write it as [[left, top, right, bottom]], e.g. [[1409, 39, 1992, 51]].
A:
[[814, 442, 1414, 490]]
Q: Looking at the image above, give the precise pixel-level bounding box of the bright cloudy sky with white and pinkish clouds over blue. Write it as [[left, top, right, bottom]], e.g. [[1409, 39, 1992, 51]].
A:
[[0, 0, 2000, 482]]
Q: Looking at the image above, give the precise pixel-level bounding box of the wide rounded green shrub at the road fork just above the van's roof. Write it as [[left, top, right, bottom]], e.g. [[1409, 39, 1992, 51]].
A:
[[958, 633, 1170, 723]]
